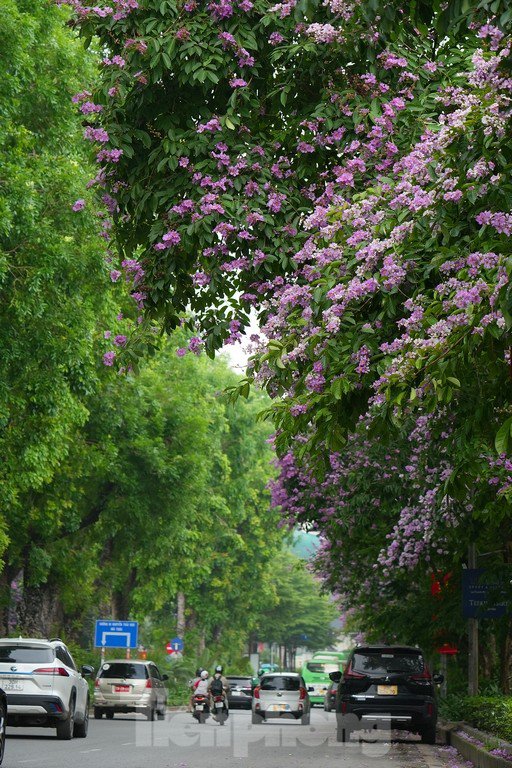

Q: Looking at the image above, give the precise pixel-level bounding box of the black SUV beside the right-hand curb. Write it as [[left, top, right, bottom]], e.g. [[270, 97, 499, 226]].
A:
[[329, 645, 443, 744]]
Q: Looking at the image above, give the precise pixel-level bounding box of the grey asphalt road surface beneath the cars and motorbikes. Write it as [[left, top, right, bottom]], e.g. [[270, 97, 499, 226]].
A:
[[2, 709, 443, 768]]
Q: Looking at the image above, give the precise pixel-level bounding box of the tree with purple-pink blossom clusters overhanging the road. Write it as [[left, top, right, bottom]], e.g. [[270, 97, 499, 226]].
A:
[[61, 0, 512, 680]]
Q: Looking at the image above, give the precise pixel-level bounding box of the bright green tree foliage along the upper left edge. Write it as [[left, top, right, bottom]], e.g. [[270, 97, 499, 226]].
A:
[[0, 0, 114, 582]]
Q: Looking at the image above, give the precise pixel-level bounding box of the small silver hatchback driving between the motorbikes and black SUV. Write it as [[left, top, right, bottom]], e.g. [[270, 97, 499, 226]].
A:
[[252, 672, 311, 725]]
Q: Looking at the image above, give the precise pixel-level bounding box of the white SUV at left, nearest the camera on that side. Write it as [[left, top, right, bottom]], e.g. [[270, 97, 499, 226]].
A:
[[0, 637, 94, 739]]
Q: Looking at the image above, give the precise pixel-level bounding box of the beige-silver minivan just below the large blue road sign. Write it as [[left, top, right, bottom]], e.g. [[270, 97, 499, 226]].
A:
[[94, 659, 168, 720]]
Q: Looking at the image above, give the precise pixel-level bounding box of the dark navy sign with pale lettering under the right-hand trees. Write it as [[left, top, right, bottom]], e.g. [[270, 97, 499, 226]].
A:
[[462, 568, 508, 619]]
